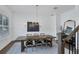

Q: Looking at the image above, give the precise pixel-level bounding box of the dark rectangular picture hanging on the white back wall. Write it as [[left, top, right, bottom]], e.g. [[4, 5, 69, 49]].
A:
[[27, 22, 39, 32]]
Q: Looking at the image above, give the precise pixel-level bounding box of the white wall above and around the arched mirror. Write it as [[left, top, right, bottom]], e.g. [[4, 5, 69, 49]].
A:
[[61, 7, 79, 25]]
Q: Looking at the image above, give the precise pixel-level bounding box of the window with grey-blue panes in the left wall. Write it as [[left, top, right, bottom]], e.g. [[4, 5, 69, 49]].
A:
[[0, 15, 9, 37]]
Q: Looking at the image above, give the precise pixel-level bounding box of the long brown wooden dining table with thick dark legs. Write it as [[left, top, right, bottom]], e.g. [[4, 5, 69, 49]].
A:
[[17, 35, 55, 52]]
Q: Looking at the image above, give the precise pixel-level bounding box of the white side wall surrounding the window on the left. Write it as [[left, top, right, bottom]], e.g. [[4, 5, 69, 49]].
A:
[[0, 6, 12, 50]]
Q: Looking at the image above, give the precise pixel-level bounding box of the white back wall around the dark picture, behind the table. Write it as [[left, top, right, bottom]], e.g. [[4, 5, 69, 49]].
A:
[[13, 13, 56, 39]]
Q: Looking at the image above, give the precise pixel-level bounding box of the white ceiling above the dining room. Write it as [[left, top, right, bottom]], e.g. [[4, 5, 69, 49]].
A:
[[7, 5, 75, 15]]
